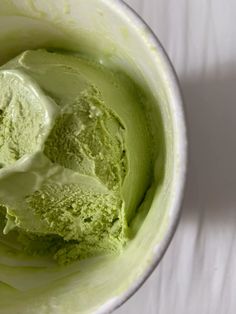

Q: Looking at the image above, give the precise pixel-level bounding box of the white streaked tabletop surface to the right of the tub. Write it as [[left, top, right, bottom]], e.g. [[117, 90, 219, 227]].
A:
[[115, 0, 236, 314]]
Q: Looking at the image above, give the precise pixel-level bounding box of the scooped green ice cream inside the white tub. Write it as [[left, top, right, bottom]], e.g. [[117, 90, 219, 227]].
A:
[[0, 50, 152, 264]]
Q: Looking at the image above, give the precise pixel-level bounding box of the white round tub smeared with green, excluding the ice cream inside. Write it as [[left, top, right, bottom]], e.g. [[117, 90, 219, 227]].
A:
[[0, 0, 187, 314]]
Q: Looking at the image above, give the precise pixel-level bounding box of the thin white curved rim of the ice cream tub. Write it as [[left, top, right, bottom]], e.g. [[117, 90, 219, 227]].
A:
[[97, 0, 188, 314]]
